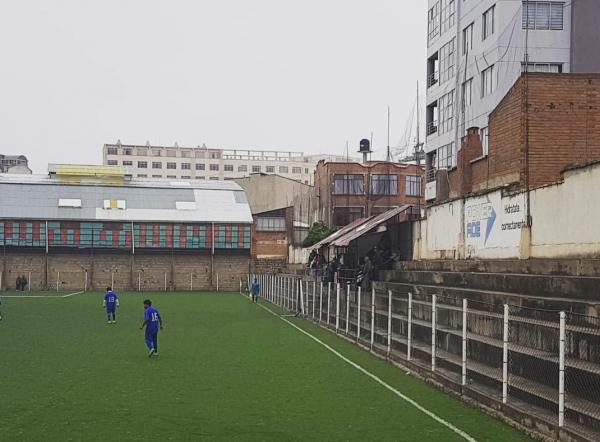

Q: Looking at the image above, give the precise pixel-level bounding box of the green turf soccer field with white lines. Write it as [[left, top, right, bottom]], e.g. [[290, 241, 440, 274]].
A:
[[0, 292, 527, 441]]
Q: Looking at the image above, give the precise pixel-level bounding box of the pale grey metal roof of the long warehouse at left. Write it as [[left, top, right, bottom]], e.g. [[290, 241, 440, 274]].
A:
[[0, 175, 252, 224]]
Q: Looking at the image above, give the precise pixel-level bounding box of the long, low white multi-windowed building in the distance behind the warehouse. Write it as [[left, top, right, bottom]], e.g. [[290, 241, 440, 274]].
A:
[[102, 141, 346, 185]]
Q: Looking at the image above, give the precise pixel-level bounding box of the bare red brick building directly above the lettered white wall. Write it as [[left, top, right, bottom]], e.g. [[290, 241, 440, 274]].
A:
[[436, 73, 600, 201]]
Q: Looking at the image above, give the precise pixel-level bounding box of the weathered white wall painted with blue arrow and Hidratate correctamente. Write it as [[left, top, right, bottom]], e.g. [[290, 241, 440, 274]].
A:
[[413, 163, 600, 259]]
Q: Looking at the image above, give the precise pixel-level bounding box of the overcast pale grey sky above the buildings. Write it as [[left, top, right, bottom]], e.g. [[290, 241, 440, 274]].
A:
[[0, 0, 427, 173]]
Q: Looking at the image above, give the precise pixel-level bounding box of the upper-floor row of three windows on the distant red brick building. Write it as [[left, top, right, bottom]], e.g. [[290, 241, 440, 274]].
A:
[[333, 174, 421, 196]]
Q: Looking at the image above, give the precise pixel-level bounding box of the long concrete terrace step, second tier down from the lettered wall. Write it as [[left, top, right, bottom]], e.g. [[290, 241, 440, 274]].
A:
[[380, 270, 600, 303]]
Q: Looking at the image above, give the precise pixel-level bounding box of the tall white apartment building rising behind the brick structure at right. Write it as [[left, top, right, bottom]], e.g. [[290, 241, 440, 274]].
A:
[[425, 0, 600, 199]]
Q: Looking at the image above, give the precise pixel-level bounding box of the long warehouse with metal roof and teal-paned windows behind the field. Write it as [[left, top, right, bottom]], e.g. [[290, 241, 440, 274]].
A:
[[0, 165, 252, 291]]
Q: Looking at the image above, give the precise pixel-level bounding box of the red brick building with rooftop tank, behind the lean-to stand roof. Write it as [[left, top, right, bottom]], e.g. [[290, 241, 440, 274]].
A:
[[315, 161, 424, 227]]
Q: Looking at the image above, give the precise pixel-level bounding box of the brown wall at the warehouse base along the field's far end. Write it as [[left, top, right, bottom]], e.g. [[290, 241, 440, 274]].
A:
[[0, 250, 250, 291]]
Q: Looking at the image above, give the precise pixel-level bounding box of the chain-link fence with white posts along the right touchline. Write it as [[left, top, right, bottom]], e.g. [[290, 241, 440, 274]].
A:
[[252, 275, 600, 440]]
